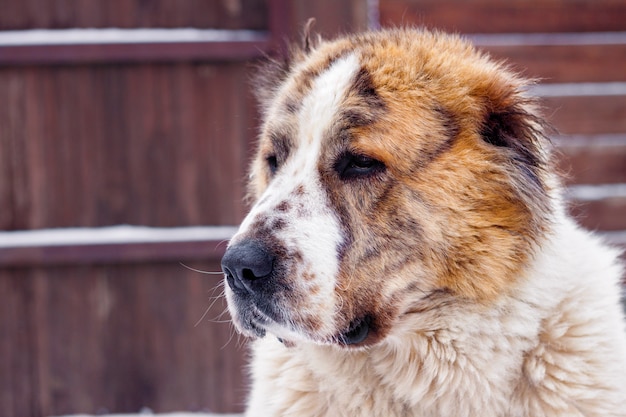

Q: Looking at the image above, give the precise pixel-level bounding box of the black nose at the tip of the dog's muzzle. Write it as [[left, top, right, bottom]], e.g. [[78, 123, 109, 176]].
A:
[[222, 240, 274, 292]]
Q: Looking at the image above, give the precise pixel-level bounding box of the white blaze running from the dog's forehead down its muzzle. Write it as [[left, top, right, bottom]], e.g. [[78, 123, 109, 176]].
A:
[[233, 54, 359, 335]]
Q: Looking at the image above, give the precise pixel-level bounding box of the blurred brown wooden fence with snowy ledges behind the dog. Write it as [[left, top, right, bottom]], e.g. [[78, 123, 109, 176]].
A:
[[0, 0, 626, 417]]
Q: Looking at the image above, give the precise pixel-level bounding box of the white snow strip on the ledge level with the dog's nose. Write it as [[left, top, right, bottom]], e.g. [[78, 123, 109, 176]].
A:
[[0, 225, 237, 249]]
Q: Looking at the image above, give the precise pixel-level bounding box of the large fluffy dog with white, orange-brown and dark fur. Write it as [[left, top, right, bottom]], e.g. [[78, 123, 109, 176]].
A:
[[222, 28, 626, 417]]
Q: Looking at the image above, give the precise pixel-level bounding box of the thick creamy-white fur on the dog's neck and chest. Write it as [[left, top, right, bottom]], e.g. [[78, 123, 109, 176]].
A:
[[248, 213, 626, 417]]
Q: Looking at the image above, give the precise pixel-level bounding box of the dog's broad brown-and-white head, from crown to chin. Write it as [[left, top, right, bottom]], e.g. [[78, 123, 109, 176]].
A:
[[223, 30, 550, 346]]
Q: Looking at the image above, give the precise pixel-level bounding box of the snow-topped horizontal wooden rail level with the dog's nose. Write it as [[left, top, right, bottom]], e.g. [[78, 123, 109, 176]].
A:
[[0, 226, 236, 268]]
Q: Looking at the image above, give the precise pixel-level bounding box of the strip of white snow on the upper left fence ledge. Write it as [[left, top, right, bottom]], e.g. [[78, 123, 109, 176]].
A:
[[0, 28, 267, 46]]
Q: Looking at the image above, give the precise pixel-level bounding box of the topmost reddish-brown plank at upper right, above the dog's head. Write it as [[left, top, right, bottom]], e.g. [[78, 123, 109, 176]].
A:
[[379, 0, 626, 33]]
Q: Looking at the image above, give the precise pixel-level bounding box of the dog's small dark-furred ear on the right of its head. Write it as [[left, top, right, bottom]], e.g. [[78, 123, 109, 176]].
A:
[[480, 88, 546, 185]]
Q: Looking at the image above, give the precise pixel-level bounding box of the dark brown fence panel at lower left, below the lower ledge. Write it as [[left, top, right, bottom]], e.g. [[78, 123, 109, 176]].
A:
[[0, 262, 246, 416]]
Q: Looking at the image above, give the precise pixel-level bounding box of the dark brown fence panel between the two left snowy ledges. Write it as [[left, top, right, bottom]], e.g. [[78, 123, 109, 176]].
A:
[[0, 63, 256, 230]]
